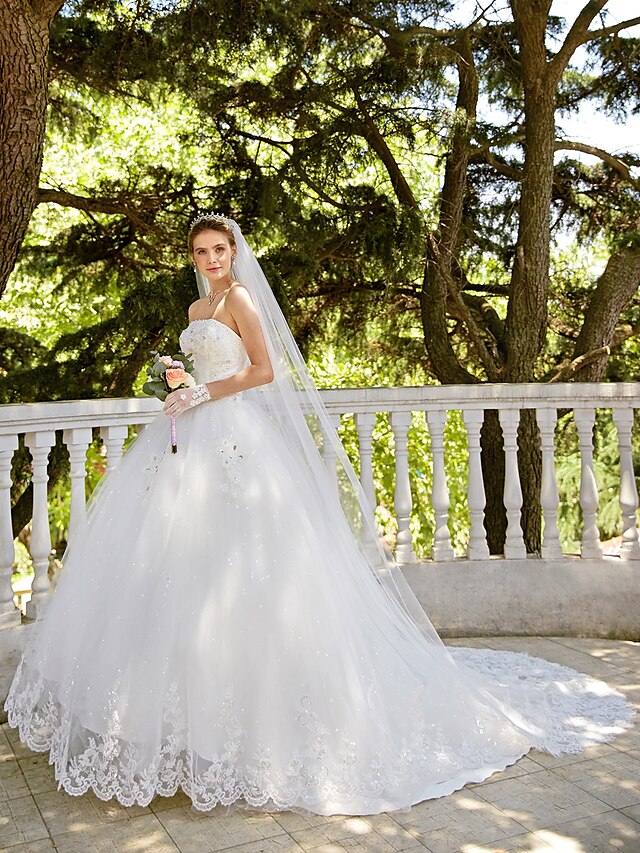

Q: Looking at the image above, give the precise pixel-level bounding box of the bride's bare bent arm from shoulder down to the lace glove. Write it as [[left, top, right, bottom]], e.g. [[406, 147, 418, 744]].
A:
[[207, 284, 273, 400]]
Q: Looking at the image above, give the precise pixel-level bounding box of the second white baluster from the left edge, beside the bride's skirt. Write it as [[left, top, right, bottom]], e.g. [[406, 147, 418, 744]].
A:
[[25, 430, 56, 619]]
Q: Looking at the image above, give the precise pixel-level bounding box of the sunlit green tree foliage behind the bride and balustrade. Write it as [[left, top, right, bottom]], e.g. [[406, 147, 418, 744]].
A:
[[0, 0, 640, 553]]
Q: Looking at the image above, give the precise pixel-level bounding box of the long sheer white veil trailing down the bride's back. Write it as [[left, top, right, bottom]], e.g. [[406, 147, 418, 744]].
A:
[[195, 215, 442, 645]]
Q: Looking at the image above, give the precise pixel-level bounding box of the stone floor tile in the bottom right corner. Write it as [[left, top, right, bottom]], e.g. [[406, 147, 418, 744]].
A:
[[535, 811, 640, 853]]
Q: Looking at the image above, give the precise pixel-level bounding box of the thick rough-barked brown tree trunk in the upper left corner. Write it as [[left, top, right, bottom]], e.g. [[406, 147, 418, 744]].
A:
[[0, 0, 62, 297]]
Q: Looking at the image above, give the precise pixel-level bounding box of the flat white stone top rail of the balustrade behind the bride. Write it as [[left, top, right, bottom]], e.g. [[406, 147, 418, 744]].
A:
[[0, 382, 640, 435]]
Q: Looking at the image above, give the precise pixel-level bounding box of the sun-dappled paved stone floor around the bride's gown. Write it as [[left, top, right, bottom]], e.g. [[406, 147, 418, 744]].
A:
[[0, 638, 640, 853]]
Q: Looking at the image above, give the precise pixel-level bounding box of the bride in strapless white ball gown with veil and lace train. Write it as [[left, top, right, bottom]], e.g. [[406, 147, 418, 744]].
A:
[[6, 214, 631, 815]]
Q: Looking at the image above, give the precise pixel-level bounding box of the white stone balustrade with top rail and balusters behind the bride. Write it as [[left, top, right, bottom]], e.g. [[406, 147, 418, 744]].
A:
[[0, 383, 640, 633]]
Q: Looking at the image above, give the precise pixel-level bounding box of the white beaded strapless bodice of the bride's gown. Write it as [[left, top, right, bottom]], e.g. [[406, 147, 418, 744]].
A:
[[180, 318, 247, 383]]
